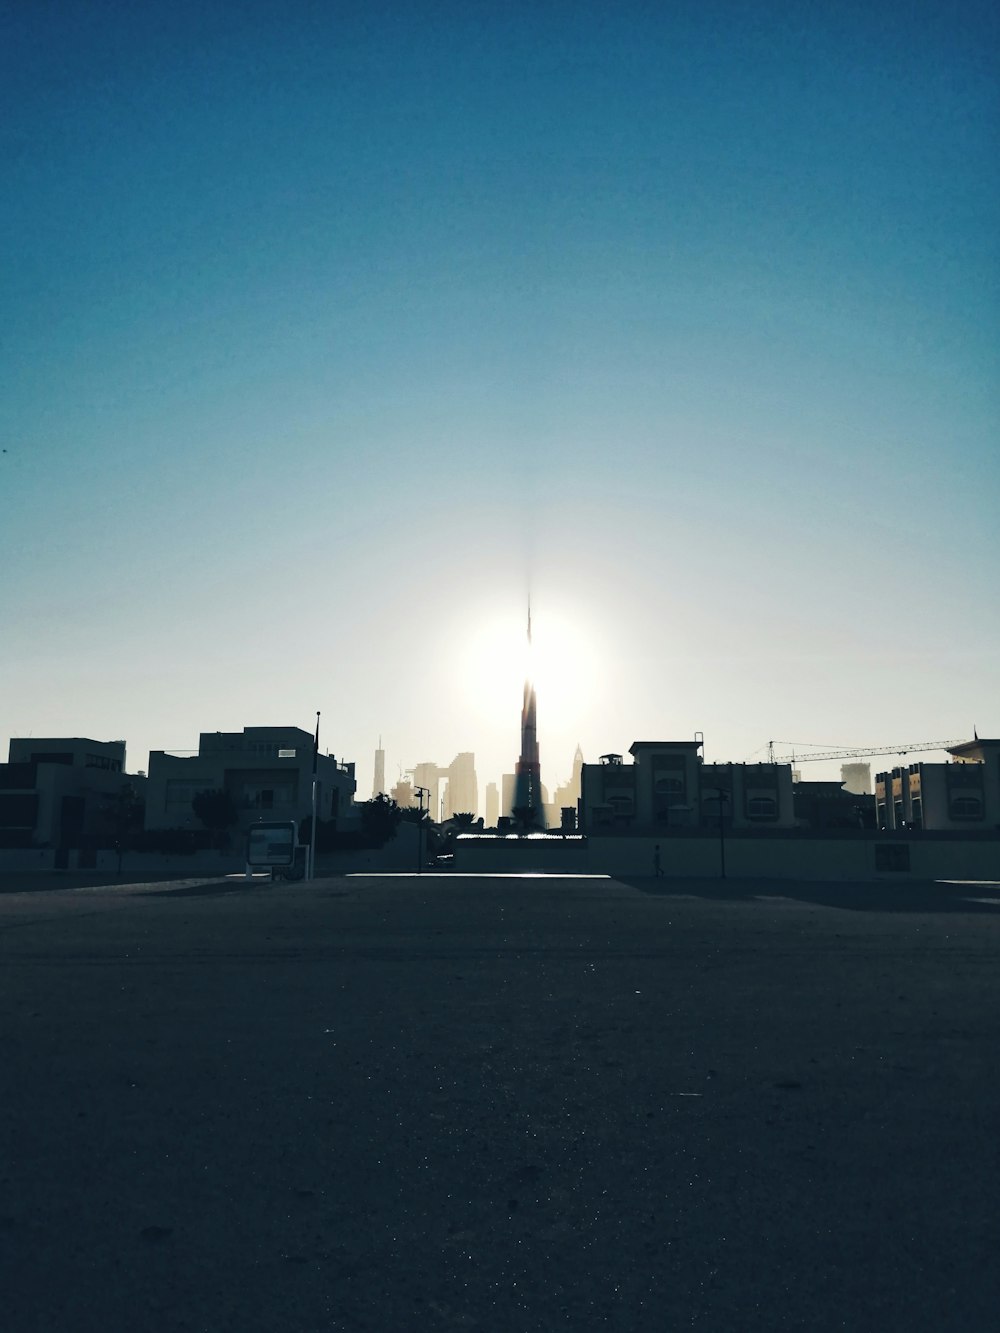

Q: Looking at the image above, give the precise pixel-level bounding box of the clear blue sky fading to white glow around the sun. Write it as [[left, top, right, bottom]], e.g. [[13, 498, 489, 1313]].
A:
[[0, 3, 1000, 794]]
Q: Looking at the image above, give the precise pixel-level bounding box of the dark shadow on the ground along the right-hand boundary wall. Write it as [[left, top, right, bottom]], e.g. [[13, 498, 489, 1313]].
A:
[[613, 874, 1000, 916]]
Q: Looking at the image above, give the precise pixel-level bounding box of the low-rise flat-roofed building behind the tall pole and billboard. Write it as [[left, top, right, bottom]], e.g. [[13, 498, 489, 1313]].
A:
[[145, 726, 357, 829]]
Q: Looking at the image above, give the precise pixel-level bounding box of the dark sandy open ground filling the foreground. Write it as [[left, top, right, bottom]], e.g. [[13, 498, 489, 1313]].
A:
[[0, 878, 1000, 1333]]
